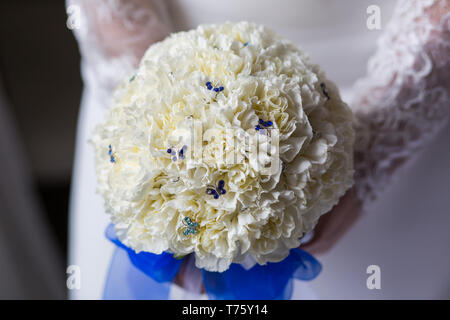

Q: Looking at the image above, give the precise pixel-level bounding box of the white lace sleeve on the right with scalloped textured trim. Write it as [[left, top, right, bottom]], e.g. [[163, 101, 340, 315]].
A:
[[352, 0, 450, 207]]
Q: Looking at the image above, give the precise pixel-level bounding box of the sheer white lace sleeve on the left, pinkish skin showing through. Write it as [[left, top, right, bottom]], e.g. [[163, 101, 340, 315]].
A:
[[66, 0, 172, 106]]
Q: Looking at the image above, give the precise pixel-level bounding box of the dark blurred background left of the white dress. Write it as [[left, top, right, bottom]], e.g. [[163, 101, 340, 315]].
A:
[[0, 0, 82, 299]]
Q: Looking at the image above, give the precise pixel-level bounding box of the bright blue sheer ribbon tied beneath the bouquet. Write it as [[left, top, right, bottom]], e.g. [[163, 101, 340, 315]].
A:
[[103, 224, 322, 300]]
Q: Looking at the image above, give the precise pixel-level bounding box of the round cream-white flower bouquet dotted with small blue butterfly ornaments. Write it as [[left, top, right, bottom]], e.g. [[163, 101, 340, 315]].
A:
[[92, 22, 354, 272]]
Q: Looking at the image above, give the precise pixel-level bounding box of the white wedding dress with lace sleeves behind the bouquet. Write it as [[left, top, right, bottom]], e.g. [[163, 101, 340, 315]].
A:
[[68, 0, 450, 299]]
